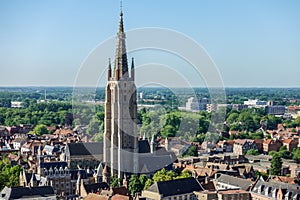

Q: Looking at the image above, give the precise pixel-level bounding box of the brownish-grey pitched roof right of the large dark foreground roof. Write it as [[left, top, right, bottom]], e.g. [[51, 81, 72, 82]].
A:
[[217, 174, 253, 191]]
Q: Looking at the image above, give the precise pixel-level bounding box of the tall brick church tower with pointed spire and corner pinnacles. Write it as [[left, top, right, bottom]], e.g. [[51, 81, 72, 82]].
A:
[[103, 11, 138, 179]]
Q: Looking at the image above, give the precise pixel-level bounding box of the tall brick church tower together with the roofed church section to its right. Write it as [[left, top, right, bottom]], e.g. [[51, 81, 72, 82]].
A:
[[103, 11, 176, 179]]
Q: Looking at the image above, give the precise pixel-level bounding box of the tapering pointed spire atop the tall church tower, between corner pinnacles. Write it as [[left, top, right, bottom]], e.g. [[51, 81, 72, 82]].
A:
[[114, 10, 129, 80]]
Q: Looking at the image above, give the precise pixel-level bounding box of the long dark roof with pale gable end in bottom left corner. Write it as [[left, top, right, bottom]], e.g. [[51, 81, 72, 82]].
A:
[[1, 186, 55, 200]]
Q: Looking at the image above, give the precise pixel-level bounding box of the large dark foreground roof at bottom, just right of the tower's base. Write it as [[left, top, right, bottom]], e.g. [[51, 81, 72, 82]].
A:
[[147, 177, 203, 197]]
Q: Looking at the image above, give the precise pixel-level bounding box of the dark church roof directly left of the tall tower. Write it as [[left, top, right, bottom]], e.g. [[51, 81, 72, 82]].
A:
[[66, 142, 103, 156]]
